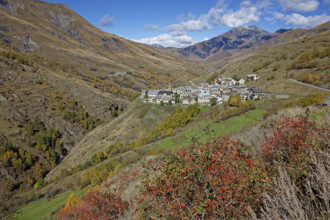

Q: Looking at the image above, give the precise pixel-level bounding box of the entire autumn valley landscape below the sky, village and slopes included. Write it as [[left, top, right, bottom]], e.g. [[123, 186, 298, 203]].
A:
[[0, 0, 330, 219]]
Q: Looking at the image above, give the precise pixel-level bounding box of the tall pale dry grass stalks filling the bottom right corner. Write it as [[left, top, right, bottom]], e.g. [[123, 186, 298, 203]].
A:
[[249, 149, 330, 220]]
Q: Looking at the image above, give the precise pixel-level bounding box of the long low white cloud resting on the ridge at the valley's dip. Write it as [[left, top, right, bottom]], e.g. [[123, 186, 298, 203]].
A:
[[135, 34, 193, 47]]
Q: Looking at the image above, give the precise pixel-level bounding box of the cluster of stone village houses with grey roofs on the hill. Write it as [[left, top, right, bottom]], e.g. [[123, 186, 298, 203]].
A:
[[141, 74, 265, 105]]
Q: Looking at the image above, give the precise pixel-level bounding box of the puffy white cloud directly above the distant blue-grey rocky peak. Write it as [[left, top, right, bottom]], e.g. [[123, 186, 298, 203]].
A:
[[221, 1, 259, 27]]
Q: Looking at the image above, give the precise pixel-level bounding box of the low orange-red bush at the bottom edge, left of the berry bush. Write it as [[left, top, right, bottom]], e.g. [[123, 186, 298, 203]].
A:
[[56, 191, 127, 220]]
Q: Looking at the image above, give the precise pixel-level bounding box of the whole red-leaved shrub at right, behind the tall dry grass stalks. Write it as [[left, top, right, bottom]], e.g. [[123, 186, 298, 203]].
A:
[[259, 116, 320, 187]]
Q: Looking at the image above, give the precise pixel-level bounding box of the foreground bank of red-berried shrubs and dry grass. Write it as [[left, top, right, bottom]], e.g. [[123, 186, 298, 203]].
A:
[[29, 103, 329, 219]]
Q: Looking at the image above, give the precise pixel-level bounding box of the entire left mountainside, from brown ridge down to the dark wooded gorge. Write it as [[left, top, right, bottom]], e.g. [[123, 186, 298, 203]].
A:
[[0, 0, 207, 217]]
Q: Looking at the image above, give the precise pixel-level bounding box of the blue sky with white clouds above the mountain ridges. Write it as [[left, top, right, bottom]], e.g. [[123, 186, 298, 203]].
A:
[[46, 0, 330, 47]]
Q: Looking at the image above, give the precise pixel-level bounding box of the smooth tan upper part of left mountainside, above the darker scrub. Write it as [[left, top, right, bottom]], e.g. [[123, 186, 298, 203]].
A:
[[0, 0, 206, 87]]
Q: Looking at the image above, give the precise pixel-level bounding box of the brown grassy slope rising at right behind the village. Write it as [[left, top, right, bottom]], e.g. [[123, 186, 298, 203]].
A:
[[210, 22, 330, 97]]
